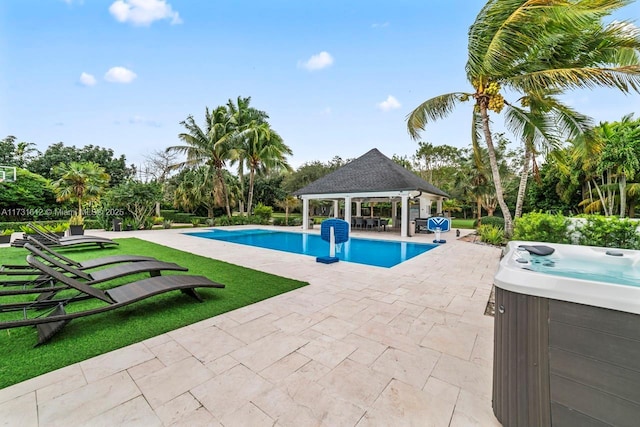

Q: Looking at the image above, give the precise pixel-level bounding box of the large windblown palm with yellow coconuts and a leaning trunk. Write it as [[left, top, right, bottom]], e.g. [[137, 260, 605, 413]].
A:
[[407, 0, 640, 236]]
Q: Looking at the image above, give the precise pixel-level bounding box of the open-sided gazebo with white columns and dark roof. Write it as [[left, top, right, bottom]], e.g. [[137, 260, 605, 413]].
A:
[[293, 148, 449, 237]]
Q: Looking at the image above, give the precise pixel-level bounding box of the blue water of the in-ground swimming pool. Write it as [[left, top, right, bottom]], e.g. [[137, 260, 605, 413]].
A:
[[185, 229, 437, 268]]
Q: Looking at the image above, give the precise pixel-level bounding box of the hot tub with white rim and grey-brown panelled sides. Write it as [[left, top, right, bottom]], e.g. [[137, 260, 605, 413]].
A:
[[493, 241, 640, 426]]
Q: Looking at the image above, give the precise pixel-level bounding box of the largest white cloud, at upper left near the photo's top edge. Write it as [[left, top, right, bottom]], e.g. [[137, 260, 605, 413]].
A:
[[109, 0, 182, 26]]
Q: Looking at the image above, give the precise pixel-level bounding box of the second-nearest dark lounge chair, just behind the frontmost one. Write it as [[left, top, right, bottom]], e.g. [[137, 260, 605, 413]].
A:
[[0, 243, 189, 300]]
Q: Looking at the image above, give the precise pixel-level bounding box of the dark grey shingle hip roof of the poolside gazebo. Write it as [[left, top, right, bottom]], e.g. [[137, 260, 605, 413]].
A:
[[293, 148, 449, 197]]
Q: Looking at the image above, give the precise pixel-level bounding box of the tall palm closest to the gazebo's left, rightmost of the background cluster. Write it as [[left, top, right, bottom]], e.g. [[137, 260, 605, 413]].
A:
[[235, 123, 293, 213]]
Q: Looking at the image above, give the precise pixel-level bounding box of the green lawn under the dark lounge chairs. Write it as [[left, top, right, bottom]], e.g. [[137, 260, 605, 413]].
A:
[[0, 238, 307, 389]]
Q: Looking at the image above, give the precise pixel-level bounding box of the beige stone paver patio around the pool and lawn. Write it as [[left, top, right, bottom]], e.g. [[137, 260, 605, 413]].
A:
[[0, 226, 500, 427]]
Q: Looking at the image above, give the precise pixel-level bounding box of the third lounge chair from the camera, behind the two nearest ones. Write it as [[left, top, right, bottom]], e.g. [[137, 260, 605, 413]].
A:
[[0, 236, 157, 276]]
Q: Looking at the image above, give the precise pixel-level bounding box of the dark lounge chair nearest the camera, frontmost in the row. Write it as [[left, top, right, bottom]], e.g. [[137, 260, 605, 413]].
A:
[[0, 255, 224, 345]]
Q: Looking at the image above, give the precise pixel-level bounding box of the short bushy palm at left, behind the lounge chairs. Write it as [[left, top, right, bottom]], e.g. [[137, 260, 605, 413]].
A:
[[52, 162, 110, 218]]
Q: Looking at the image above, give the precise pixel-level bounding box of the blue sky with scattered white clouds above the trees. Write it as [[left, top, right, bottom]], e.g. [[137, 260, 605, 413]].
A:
[[0, 0, 640, 171]]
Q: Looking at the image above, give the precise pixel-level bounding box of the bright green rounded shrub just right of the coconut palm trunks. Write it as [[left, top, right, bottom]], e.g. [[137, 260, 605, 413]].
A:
[[513, 212, 571, 243]]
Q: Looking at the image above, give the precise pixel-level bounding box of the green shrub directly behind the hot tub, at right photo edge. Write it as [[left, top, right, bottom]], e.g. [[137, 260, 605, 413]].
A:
[[576, 215, 640, 249]]
